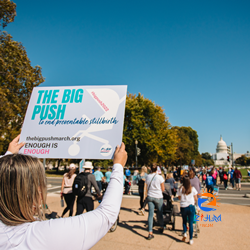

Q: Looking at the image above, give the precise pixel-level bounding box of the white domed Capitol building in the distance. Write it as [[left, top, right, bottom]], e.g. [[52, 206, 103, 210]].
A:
[[212, 136, 250, 166]]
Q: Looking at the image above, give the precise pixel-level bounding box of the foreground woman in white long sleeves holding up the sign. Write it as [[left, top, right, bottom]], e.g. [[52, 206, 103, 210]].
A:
[[0, 137, 127, 250]]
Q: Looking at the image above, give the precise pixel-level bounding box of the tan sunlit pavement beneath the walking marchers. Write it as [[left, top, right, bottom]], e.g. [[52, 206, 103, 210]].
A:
[[47, 194, 250, 250]]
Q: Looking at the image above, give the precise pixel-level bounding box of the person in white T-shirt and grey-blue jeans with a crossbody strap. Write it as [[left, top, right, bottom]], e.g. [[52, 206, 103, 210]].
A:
[[146, 163, 165, 240]]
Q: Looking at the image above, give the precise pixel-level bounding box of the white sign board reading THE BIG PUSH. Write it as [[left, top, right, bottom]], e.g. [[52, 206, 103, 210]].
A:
[[20, 86, 127, 159]]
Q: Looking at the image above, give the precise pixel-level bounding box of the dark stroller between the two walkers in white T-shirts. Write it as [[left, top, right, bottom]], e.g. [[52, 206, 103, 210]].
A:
[[154, 183, 178, 230]]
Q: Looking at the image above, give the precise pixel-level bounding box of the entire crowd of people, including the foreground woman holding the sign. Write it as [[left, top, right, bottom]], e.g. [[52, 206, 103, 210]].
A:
[[0, 137, 245, 249]]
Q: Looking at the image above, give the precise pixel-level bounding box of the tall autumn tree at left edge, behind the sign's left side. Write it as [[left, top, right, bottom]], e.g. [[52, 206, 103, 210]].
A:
[[0, 1, 44, 154]]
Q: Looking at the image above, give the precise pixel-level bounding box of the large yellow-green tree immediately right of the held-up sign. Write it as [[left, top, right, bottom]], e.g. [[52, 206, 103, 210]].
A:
[[123, 93, 177, 166]]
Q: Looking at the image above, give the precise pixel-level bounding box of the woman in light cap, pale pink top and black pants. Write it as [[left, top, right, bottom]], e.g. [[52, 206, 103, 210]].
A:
[[61, 163, 76, 217]]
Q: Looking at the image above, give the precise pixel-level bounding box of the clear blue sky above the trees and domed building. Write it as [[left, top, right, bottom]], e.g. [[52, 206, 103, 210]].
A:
[[5, 0, 250, 153]]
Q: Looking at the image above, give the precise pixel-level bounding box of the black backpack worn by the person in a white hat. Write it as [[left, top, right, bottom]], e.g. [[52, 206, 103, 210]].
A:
[[72, 173, 90, 197]]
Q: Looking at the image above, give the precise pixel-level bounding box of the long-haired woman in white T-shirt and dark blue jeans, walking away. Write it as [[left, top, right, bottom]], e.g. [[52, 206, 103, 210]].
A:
[[177, 176, 197, 245]]
